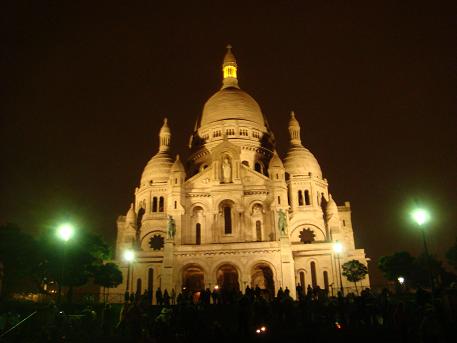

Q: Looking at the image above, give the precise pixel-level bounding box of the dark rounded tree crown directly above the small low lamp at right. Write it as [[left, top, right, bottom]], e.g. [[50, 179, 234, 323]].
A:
[[378, 251, 416, 281]]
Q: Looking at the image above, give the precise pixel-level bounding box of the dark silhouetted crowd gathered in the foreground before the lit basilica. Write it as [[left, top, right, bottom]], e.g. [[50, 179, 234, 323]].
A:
[[1, 286, 457, 343]]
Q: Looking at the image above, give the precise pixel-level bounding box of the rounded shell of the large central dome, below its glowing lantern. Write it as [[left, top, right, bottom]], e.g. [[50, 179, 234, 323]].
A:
[[200, 87, 265, 127]]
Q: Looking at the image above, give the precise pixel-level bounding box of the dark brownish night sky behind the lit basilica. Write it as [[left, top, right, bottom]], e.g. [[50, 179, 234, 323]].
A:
[[0, 1, 457, 282]]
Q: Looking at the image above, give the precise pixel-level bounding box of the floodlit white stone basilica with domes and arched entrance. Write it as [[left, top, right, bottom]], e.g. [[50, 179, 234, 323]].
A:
[[112, 46, 369, 297]]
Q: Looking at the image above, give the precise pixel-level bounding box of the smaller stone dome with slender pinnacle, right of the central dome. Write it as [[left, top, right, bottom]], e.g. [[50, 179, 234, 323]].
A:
[[284, 111, 322, 179]]
